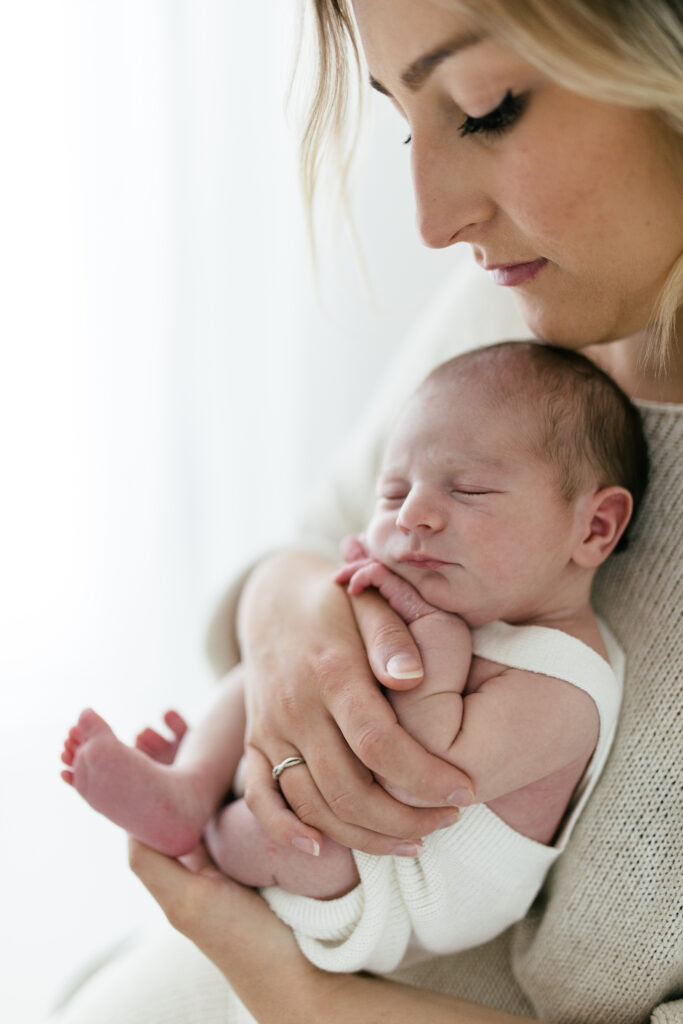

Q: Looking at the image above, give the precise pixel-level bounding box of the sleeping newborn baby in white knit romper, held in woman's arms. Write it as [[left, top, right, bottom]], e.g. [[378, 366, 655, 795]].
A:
[[62, 342, 647, 972]]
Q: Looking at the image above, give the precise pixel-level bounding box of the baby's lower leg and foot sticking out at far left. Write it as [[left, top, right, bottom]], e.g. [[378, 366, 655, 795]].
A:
[[61, 670, 245, 856]]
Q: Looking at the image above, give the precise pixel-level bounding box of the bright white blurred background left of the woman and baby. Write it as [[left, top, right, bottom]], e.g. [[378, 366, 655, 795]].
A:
[[0, 0, 458, 1024]]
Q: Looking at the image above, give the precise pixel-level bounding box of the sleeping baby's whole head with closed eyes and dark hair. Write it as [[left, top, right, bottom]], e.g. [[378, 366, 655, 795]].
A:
[[366, 342, 648, 626]]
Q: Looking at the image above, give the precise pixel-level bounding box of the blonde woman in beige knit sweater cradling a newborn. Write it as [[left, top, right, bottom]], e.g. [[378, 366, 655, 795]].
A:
[[50, 0, 683, 1024]]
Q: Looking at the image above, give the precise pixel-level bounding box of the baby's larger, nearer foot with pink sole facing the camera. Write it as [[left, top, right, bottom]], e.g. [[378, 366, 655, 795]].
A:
[[61, 709, 211, 857]]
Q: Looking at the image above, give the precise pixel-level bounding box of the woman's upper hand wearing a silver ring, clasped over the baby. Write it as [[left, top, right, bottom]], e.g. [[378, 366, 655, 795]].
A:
[[240, 553, 472, 855]]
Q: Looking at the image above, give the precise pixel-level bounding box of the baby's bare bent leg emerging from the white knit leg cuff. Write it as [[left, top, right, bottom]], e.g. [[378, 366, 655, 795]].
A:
[[204, 800, 358, 899]]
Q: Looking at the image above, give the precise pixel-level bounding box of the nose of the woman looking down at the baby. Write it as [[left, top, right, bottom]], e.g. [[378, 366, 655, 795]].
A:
[[412, 132, 495, 249]]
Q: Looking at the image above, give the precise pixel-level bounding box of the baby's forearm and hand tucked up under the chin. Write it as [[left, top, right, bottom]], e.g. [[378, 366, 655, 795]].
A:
[[335, 558, 472, 757]]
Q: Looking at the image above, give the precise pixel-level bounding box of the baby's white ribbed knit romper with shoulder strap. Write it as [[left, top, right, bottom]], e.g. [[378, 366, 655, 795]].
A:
[[263, 623, 624, 974]]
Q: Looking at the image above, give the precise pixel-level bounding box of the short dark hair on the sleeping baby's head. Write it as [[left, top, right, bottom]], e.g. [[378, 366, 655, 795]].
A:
[[427, 341, 649, 551]]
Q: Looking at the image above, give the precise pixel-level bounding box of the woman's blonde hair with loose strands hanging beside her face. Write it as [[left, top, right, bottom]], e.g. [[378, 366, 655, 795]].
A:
[[301, 0, 683, 370]]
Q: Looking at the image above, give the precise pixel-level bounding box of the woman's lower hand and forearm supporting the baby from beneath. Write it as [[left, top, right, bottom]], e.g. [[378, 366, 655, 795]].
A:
[[129, 839, 531, 1024]]
